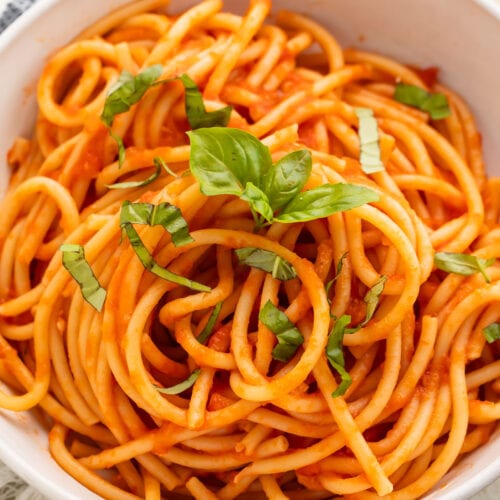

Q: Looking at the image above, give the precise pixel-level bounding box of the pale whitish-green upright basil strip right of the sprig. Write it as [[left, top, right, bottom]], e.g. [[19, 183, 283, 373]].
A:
[[354, 108, 385, 174]]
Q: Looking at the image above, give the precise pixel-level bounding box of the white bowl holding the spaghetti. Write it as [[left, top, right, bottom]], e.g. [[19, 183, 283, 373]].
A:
[[0, 0, 500, 500]]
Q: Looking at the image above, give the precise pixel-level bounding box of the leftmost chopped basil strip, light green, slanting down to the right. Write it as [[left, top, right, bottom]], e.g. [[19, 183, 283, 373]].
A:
[[59, 244, 106, 312]]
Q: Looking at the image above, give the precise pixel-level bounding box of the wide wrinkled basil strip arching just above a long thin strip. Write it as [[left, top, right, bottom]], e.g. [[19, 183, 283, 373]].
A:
[[120, 200, 193, 247]]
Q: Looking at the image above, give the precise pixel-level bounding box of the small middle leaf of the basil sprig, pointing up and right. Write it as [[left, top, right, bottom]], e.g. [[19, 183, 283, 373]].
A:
[[262, 149, 312, 212]]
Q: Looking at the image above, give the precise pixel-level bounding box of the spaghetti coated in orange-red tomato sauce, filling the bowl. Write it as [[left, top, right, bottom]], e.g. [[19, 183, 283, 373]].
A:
[[0, 0, 500, 499]]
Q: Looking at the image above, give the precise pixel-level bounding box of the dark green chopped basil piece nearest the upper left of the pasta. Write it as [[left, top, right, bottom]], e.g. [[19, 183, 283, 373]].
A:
[[101, 64, 163, 127]]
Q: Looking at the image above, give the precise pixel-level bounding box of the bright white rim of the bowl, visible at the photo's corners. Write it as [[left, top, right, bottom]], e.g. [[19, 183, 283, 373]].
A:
[[0, 0, 500, 500]]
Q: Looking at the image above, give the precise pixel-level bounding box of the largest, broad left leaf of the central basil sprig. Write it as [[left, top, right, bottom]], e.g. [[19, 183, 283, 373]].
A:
[[187, 127, 272, 196]]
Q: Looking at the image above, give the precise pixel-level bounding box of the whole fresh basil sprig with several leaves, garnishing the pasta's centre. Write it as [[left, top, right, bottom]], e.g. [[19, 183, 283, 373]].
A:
[[188, 127, 379, 227]]
